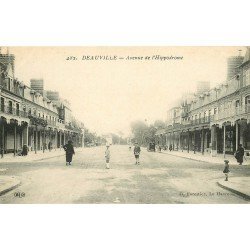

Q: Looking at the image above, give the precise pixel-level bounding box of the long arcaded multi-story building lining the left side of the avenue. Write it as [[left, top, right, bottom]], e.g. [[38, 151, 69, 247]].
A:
[[0, 50, 84, 156]]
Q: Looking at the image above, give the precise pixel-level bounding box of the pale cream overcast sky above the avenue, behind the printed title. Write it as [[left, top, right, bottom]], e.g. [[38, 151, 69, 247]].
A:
[[5, 47, 245, 137]]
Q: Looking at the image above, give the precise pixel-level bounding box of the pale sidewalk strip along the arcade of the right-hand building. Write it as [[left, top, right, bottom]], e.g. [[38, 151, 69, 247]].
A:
[[161, 150, 250, 167]]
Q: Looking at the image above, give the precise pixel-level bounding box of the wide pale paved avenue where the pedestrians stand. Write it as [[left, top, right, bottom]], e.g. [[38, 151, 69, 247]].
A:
[[0, 146, 250, 204]]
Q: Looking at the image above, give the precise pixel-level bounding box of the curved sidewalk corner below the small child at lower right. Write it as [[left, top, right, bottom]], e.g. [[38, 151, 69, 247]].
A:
[[217, 177, 250, 201]]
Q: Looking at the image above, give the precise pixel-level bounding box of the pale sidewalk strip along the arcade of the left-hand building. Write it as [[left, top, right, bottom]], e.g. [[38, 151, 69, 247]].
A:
[[0, 148, 84, 166]]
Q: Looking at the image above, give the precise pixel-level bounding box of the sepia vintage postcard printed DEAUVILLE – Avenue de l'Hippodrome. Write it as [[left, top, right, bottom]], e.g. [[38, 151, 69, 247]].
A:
[[0, 46, 250, 204]]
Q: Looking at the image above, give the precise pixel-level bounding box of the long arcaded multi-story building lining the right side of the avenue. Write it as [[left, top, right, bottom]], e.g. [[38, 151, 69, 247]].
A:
[[156, 48, 250, 156]]
